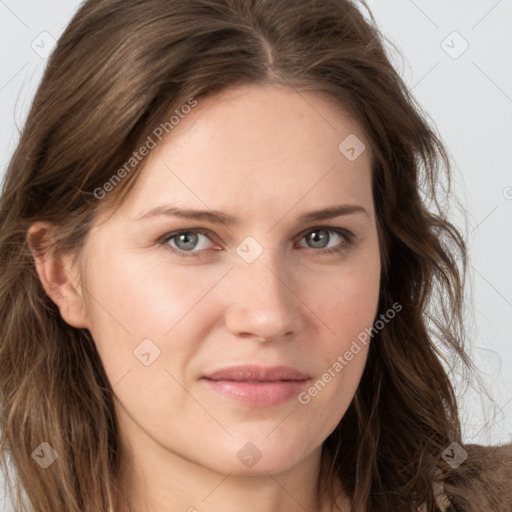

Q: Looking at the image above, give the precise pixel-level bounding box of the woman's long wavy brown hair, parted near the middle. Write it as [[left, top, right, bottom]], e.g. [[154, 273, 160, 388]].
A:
[[0, 0, 470, 512]]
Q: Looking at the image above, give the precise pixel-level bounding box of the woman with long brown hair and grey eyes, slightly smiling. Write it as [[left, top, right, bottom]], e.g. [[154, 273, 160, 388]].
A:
[[0, 0, 512, 512]]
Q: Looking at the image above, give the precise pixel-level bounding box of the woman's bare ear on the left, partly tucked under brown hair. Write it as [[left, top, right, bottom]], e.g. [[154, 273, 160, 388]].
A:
[[27, 221, 89, 328]]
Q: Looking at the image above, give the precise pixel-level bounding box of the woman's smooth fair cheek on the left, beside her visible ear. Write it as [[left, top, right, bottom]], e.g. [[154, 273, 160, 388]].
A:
[[81, 250, 227, 383]]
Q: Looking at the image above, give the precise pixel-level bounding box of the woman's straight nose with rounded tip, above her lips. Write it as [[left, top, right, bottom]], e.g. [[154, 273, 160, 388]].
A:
[[223, 249, 305, 341]]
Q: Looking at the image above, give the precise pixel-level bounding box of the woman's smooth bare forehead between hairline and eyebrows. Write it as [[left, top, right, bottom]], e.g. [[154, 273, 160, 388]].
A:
[[116, 85, 371, 222]]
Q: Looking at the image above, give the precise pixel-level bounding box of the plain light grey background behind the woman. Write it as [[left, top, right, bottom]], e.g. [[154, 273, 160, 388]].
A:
[[0, 0, 512, 500]]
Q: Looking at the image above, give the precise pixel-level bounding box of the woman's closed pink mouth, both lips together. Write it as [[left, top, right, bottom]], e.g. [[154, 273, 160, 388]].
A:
[[201, 365, 310, 407]]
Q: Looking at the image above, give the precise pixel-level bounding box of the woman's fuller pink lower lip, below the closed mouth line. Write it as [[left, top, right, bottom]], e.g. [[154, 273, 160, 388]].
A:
[[201, 379, 309, 407]]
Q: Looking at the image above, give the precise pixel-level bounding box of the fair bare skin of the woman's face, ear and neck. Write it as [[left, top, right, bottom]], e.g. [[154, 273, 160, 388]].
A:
[[31, 85, 380, 512]]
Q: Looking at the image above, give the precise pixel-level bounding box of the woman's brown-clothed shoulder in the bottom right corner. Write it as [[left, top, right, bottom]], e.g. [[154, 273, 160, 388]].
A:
[[444, 444, 512, 512]]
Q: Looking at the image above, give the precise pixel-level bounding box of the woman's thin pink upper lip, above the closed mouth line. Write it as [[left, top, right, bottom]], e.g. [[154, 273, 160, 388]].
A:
[[204, 365, 309, 382]]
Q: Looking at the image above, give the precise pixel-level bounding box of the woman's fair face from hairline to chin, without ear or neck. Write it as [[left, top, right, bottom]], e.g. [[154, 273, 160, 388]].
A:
[[75, 86, 380, 474]]
